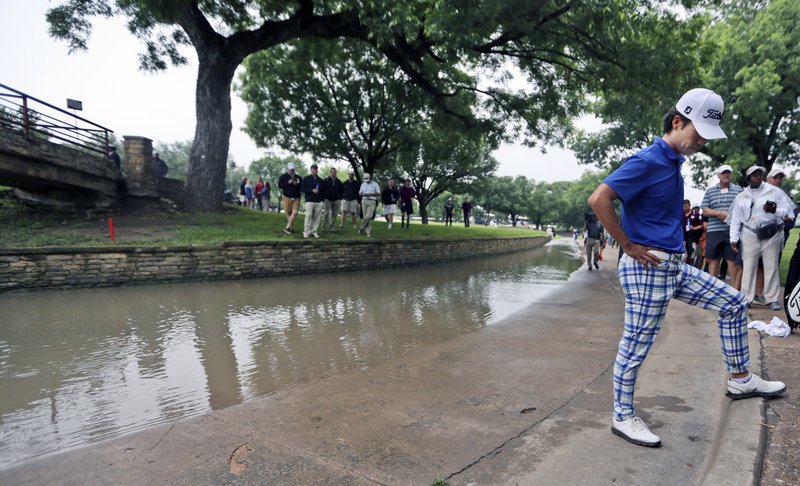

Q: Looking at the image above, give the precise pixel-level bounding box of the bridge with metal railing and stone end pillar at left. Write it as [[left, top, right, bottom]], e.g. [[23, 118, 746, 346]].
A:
[[0, 84, 183, 210]]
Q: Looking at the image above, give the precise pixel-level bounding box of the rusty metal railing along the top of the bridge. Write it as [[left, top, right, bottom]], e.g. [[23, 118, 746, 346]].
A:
[[0, 84, 114, 156]]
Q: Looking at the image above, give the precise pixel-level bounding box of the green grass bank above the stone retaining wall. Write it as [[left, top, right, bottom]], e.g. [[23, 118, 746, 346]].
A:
[[0, 191, 544, 248]]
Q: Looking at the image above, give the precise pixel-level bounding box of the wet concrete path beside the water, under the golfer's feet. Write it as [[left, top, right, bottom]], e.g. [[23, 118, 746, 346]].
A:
[[0, 252, 764, 485]]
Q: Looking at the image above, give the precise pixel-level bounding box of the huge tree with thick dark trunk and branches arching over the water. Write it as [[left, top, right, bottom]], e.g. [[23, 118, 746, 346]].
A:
[[48, 0, 696, 210]]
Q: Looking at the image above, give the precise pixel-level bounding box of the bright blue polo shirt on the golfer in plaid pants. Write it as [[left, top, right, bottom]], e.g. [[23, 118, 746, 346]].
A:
[[603, 137, 685, 253]]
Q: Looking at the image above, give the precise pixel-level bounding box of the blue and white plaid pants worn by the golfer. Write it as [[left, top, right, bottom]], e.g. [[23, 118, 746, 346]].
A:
[[614, 254, 750, 420]]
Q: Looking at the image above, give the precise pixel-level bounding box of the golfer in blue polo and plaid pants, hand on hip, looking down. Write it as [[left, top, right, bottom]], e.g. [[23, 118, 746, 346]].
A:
[[589, 89, 786, 447]]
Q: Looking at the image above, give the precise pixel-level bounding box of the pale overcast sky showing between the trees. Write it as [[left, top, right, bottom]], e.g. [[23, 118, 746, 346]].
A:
[[0, 0, 702, 202]]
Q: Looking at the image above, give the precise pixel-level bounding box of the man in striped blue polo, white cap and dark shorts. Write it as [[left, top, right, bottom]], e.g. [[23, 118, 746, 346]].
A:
[[700, 164, 742, 287]]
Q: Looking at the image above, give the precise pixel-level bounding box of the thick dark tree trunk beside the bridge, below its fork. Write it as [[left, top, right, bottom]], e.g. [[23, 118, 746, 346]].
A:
[[184, 54, 237, 211]]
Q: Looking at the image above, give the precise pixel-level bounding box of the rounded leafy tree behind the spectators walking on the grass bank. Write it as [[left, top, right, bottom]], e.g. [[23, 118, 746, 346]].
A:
[[241, 39, 425, 180]]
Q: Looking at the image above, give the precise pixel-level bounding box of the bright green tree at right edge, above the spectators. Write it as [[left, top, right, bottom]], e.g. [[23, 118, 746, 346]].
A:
[[694, 0, 800, 182]]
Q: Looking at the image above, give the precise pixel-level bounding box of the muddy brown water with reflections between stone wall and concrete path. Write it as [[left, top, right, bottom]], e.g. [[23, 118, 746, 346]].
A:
[[0, 240, 580, 468]]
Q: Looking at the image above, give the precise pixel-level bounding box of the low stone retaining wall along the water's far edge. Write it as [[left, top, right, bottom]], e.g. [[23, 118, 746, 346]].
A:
[[0, 236, 549, 292]]
